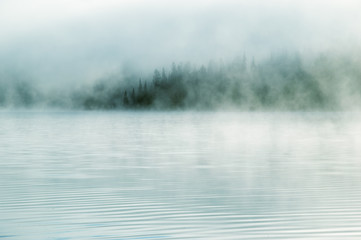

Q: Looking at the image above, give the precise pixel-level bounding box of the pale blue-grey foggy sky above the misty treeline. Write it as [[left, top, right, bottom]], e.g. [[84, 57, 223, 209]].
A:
[[0, 0, 361, 83]]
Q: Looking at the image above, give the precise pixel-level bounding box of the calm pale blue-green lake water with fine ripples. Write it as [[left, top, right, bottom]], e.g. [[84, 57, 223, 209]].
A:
[[0, 111, 361, 240]]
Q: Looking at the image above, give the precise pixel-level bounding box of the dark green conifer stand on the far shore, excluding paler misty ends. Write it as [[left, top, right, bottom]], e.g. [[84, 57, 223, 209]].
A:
[[84, 54, 346, 110]]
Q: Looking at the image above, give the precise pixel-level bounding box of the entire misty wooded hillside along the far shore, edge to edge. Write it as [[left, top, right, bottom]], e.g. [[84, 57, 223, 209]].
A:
[[0, 54, 361, 110]]
